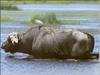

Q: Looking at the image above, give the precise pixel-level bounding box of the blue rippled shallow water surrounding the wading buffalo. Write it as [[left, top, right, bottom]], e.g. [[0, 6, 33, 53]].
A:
[[0, 3, 100, 75]]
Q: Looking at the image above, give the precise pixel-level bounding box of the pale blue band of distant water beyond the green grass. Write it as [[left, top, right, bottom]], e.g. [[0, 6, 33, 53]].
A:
[[18, 4, 100, 11]]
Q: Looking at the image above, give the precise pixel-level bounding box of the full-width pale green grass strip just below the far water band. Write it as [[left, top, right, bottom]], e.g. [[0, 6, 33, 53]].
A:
[[1, 10, 100, 18]]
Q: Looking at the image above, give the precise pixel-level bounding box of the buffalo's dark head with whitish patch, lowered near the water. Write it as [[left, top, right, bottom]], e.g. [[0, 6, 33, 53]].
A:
[[1, 32, 19, 53]]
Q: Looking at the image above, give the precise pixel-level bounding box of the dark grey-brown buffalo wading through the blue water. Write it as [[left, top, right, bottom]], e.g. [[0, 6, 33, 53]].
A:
[[2, 26, 94, 59]]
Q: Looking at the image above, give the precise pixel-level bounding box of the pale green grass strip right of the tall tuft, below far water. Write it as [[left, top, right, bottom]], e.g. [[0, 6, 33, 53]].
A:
[[57, 11, 100, 18]]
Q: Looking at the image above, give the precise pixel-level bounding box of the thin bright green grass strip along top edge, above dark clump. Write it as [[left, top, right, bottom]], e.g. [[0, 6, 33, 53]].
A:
[[1, 0, 100, 5]]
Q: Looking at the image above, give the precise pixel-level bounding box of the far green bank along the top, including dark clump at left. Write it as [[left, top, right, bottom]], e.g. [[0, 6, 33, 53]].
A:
[[0, 0, 100, 10]]
